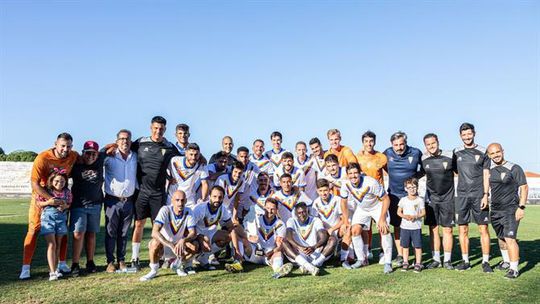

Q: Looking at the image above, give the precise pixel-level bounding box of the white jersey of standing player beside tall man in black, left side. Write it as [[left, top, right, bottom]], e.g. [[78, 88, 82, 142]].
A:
[[168, 156, 208, 207]]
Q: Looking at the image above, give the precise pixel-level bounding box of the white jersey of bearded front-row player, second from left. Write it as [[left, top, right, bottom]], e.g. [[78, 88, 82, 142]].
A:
[[193, 202, 231, 235]]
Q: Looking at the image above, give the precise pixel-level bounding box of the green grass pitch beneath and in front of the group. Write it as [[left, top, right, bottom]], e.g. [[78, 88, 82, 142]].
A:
[[0, 199, 540, 303]]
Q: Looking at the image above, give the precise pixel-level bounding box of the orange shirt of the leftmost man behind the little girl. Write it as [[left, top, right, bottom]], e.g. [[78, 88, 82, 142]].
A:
[[30, 149, 79, 194]]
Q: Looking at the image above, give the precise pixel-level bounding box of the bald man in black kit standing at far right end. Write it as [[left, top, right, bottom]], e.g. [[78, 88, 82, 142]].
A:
[[487, 143, 529, 279]]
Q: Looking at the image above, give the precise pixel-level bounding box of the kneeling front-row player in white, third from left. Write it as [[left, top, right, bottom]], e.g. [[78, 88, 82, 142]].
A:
[[229, 198, 293, 279]]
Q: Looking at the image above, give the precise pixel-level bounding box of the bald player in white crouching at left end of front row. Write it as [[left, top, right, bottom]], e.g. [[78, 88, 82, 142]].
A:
[[140, 191, 198, 281]]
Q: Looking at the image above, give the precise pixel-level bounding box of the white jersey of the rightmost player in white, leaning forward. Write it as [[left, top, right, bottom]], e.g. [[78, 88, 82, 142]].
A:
[[340, 175, 386, 211]]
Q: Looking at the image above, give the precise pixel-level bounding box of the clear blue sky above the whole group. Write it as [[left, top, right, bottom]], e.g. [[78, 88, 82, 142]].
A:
[[0, 0, 540, 171]]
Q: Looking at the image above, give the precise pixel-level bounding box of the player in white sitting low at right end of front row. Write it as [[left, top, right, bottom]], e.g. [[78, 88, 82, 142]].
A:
[[283, 203, 336, 276]]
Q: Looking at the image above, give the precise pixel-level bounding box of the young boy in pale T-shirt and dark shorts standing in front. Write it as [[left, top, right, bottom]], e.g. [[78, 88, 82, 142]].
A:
[[398, 177, 426, 272]]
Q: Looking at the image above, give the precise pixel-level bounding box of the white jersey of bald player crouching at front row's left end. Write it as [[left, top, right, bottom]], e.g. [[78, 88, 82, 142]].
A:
[[154, 205, 195, 243]]
